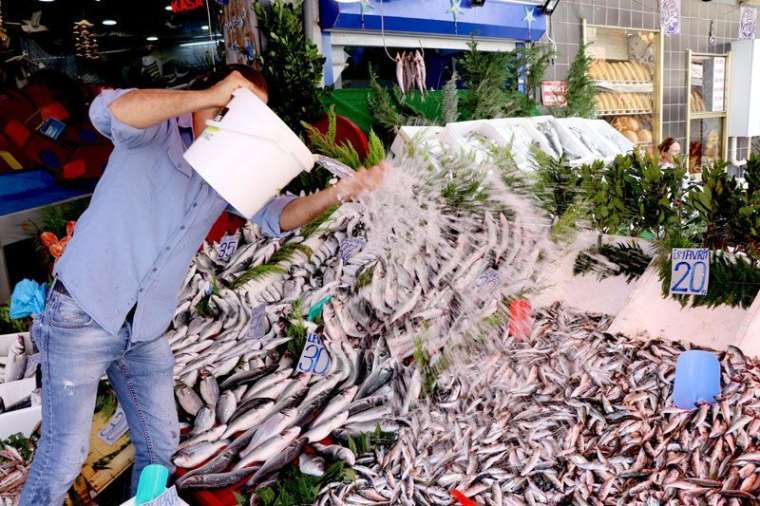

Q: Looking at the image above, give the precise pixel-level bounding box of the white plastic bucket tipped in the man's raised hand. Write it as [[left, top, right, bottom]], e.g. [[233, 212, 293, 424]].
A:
[[184, 88, 314, 217]]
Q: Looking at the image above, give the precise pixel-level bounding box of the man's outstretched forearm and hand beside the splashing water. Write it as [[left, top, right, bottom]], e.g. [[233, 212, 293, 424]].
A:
[[280, 162, 390, 232]]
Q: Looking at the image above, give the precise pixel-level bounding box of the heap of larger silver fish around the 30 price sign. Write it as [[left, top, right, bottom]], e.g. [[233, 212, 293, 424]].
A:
[[167, 141, 548, 489]]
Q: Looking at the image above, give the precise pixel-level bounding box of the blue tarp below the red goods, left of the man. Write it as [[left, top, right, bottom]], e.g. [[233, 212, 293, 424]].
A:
[[0, 170, 92, 216]]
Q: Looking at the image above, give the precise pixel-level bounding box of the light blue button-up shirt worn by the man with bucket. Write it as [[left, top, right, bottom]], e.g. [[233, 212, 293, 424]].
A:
[[55, 90, 294, 341]]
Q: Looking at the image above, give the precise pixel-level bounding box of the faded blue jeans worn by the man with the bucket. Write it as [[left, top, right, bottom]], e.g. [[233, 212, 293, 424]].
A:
[[21, 286, 179, 506]]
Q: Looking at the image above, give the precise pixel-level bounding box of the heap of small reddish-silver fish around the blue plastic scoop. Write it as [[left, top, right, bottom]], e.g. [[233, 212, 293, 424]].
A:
[[326, 304, 760, 506]]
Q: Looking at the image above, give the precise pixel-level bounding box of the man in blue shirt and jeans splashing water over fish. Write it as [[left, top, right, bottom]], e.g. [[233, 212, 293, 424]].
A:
[[21, 66, 388, 506]]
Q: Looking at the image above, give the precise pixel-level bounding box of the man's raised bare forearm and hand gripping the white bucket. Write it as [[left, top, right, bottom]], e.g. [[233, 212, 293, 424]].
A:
[[110, 71, 257, 128]]
